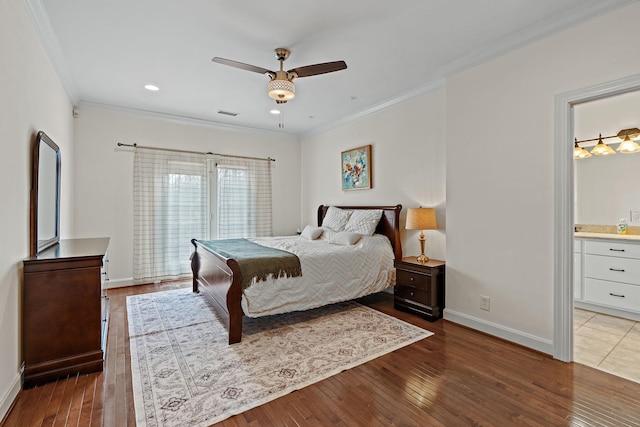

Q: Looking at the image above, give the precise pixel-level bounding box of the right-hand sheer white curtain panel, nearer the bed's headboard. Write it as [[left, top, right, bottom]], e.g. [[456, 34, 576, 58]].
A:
[[216, 157, 273, 239]]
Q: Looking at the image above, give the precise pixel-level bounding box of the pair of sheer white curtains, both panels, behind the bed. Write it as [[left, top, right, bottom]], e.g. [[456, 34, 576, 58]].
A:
[[133, 147, 273, 281]]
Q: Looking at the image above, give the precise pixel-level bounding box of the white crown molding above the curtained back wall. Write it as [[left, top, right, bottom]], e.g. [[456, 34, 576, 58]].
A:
[[78, 101, 300, 139]]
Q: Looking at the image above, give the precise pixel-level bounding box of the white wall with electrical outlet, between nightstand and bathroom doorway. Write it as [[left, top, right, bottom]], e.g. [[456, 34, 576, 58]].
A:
[[445, 3, 640, 352]]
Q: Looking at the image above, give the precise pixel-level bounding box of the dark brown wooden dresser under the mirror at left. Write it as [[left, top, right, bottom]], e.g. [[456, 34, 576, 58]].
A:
[[22, 237, 109, 388]]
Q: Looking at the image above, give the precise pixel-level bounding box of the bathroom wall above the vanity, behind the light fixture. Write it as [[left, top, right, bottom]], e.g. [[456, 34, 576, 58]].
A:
[[573, 92, 640, 226]]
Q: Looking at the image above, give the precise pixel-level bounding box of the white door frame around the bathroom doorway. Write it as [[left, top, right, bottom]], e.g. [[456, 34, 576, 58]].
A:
[[553, 74, 640, 362]]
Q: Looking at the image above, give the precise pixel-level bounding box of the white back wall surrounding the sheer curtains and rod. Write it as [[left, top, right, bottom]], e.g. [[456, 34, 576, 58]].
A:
[[74, 106, 301, 286]]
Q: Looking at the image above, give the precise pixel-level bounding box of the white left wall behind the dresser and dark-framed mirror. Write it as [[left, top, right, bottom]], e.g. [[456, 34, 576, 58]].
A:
[[0, 0, 73, 419]]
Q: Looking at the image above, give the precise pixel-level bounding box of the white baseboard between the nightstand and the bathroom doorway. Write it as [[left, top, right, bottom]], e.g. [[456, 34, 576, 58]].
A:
[[444, 308, 554, 355]]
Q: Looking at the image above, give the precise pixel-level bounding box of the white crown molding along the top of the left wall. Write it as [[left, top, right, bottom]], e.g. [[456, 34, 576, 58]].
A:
[[25, 0, 80, 105]]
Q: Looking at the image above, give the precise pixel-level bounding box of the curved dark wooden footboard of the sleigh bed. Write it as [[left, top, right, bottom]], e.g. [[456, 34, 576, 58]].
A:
[[191, 239, 243, 344]]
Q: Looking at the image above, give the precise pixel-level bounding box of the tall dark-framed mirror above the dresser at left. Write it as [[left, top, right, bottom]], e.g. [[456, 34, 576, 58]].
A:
[[30, 131, 60, 256]]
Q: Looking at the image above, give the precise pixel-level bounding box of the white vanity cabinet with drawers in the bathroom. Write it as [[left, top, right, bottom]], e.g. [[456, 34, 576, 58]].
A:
[[574, 239, 640, 320]]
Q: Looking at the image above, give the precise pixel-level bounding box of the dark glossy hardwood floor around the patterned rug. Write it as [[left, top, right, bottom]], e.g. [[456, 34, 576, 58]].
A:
[[2, 282, 640, 427]]
